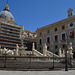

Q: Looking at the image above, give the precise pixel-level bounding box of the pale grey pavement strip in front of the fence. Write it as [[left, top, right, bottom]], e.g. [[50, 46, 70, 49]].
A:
[[0, 70, 75, 75]]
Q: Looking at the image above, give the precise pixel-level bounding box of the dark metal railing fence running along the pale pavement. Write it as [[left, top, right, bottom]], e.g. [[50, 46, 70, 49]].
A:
[[0, 55, 75, 69]]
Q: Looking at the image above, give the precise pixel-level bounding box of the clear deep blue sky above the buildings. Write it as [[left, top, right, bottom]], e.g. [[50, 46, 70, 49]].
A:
[[0, 0, 75, 31]]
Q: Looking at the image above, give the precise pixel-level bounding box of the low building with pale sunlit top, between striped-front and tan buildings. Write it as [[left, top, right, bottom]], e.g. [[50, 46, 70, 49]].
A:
[[23, 29, 37, 51]]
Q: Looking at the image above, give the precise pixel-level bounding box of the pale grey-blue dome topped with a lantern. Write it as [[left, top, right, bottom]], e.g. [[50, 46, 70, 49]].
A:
[[0, 4, 14, 20]]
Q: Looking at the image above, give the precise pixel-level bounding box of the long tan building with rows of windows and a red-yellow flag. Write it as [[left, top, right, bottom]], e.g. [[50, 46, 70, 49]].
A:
[[36, 8, 75, 55]]
